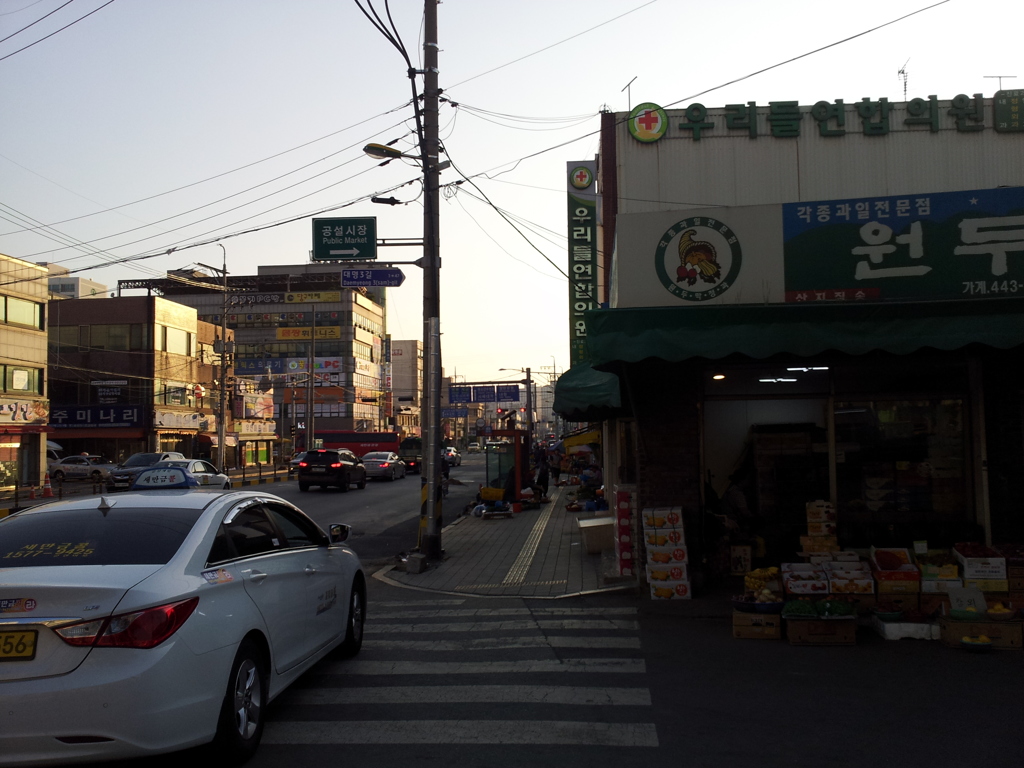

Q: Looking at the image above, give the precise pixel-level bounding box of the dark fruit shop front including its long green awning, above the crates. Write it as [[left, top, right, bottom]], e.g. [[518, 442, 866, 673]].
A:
[[588, 301, 1024, 563]]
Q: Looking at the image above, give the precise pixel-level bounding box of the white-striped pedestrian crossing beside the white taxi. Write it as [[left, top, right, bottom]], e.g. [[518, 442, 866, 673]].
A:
[[263, 599, 658, 759]]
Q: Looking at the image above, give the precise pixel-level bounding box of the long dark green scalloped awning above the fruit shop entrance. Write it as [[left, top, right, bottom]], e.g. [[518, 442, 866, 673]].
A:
[[589, 298, 1024, 368]]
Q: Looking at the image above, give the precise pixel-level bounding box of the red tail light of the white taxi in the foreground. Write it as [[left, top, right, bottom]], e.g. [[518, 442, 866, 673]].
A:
[[54, 597, 199, 648]]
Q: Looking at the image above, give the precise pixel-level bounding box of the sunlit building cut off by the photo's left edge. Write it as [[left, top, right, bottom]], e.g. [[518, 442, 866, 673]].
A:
[[0, 254, 49, 486]]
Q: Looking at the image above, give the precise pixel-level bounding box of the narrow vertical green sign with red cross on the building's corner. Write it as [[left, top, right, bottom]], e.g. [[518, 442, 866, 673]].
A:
[[566, 160, 598, 366]]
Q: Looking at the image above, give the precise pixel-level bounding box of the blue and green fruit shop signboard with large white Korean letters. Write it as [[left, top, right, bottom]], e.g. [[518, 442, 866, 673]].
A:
[[782, 187, 1024, 302]]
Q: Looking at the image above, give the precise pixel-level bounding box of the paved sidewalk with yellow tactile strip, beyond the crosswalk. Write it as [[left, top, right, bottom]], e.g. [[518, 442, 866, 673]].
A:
[[374, 486, 636, 598]]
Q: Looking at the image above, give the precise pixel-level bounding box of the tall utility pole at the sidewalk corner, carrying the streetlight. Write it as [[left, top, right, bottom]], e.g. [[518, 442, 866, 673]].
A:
[[420, 0, 441, 560]]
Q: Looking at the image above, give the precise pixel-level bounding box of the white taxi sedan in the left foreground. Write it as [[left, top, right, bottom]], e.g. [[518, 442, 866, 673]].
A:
[[0, 490, 366, 766]]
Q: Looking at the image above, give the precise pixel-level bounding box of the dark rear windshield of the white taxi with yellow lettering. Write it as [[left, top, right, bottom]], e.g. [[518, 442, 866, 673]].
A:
[[0, 507, 202, 570]]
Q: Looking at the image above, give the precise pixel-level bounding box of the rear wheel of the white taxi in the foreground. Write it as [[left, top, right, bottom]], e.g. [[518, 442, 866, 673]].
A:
[[212, 640, 267, 765]]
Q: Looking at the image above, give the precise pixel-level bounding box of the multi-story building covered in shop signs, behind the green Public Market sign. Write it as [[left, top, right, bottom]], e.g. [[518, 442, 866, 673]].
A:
[[118, 264, 388, 457]]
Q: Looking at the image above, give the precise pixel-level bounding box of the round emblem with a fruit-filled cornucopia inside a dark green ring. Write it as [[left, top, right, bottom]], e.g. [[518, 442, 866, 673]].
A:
[[654, 216, 743, 301]]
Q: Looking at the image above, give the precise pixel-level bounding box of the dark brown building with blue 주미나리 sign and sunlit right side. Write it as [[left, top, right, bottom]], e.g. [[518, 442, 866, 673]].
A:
[[49, 296, 234, 466]]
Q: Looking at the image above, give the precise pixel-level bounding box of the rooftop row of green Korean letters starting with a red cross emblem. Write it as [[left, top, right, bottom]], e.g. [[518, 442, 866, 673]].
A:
[[627, 90, 1024, 143]]
